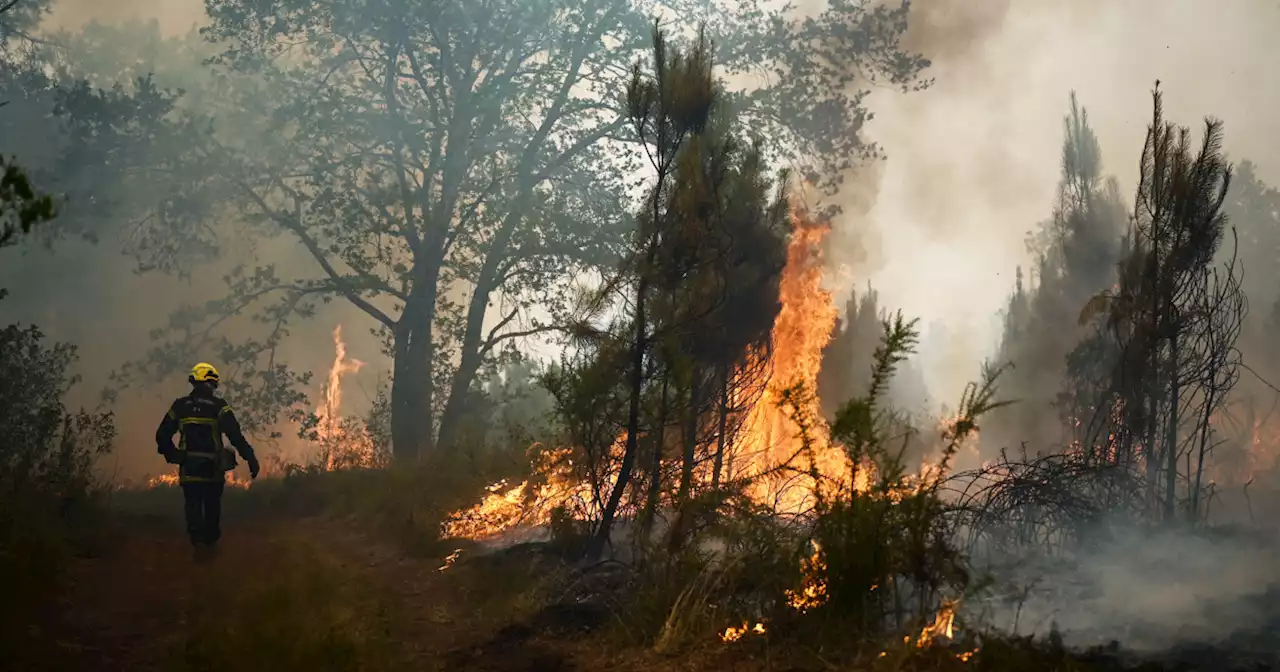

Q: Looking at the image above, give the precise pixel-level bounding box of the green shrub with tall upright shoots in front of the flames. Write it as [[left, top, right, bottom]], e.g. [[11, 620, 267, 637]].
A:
[[783, 314, 1005, 639]]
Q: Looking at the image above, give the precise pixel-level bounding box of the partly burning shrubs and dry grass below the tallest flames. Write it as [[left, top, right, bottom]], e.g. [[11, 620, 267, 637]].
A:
[[593, 315, 1024, 669]]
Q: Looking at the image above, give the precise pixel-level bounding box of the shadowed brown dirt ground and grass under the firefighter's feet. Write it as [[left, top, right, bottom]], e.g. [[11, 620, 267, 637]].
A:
[[20, 502, 665, 672]]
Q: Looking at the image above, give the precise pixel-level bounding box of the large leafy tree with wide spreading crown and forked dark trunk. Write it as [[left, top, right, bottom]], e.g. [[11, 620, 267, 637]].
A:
[[132, 0, 925, 457]]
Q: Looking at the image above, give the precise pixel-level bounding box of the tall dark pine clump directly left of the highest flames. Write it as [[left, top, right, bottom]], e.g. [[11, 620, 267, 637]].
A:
[[588, 24, 787, 556]]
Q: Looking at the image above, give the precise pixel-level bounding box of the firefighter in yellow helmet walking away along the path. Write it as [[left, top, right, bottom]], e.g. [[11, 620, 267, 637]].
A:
[[156, 362, 259, 561]]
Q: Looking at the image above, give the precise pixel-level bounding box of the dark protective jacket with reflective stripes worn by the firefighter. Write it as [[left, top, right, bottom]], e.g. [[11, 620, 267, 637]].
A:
[[156, 385, 256, 483]]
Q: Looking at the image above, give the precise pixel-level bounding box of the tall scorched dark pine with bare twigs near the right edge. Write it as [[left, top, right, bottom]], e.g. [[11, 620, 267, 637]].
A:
[[1082, 84, 1245, 520]]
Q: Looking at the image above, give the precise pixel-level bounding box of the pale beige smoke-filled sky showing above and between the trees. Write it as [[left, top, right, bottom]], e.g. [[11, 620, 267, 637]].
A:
[[45, 0, 1280, 407]]
